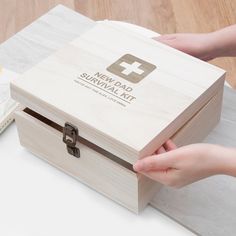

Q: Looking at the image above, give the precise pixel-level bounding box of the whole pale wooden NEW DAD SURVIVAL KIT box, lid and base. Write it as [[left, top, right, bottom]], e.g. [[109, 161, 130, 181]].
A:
[[11, 22, 225, 212]]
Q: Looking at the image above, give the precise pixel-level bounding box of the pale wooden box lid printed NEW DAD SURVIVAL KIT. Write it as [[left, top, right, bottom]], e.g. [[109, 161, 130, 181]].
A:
[[11, 22, 225, 163]]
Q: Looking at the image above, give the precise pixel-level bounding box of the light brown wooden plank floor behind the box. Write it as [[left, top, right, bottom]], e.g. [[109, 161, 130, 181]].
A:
[[0, 0, 236, 88]]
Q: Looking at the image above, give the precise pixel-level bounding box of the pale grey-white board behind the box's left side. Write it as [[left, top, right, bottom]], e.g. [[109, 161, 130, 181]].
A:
[[0, 5, 94, 73]]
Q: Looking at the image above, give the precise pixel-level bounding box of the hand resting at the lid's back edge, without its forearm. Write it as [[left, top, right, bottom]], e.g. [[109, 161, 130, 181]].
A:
[[154, 33, 218, 61]]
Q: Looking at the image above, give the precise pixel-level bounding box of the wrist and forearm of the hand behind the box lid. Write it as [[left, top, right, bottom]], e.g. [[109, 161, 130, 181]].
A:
[[211, 25, 236, 57]]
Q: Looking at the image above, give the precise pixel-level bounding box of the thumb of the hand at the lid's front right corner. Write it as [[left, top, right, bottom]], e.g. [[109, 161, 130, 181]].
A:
[[133, 153, 173, 172]]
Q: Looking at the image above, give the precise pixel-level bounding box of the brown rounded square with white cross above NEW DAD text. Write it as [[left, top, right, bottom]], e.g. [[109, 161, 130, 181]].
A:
[[107, 54, 156, 83]]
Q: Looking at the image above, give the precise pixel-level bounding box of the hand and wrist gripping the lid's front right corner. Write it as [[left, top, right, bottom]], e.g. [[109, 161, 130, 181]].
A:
[[134, 140, 236, 188]]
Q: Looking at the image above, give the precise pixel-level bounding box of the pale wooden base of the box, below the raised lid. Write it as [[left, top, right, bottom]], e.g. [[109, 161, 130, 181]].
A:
[[12, 86, 222, 213]]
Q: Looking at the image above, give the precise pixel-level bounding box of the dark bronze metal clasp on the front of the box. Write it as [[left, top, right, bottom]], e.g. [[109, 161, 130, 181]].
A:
[[63, 122, 80, 158]]
